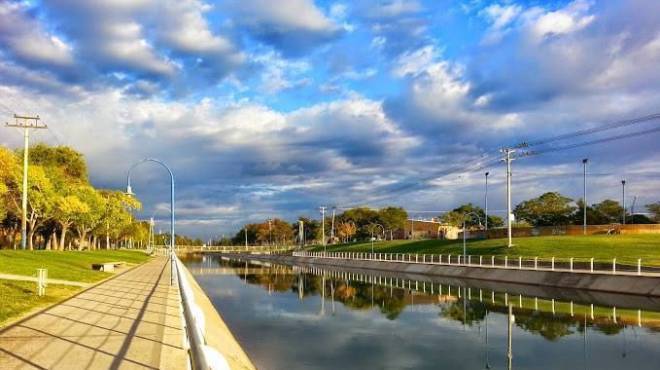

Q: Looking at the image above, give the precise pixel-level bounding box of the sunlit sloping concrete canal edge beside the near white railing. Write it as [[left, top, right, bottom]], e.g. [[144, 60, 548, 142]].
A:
[[182, 264, 256, 370]]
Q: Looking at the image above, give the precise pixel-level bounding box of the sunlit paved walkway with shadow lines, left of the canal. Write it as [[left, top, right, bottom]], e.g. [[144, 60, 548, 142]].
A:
[[0, 257, 187, 370]]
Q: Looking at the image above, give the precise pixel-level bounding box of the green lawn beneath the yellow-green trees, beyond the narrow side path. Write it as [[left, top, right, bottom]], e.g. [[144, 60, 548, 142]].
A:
[[0, 250, 149, 282]]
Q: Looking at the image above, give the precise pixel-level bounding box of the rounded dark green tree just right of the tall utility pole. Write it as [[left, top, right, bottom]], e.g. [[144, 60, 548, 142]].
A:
[[514, 192, 575, 226]]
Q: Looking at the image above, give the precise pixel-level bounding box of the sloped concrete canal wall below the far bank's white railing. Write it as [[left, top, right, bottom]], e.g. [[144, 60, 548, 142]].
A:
[[235, 255, 660, 297]]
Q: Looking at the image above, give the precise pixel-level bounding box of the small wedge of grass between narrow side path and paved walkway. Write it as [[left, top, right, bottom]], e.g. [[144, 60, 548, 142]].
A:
[[0, 280, 80, 327]]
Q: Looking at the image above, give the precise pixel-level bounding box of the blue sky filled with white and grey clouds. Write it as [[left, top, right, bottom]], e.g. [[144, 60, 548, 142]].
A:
[[0, 0, 660, 238]]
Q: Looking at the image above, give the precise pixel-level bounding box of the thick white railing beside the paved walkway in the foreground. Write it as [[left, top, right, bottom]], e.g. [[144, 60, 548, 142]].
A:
[[174, 257, 229, 370]]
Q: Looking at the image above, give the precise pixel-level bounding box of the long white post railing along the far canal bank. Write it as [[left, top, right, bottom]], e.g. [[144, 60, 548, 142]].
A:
[[293, 251, 660, 276]]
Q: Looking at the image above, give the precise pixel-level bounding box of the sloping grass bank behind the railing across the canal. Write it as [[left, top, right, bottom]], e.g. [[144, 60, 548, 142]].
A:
[[311, 234, 660, 266]]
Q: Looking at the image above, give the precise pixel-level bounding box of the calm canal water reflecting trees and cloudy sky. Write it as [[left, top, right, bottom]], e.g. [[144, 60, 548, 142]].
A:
[[184, 256, 660, 370]]
